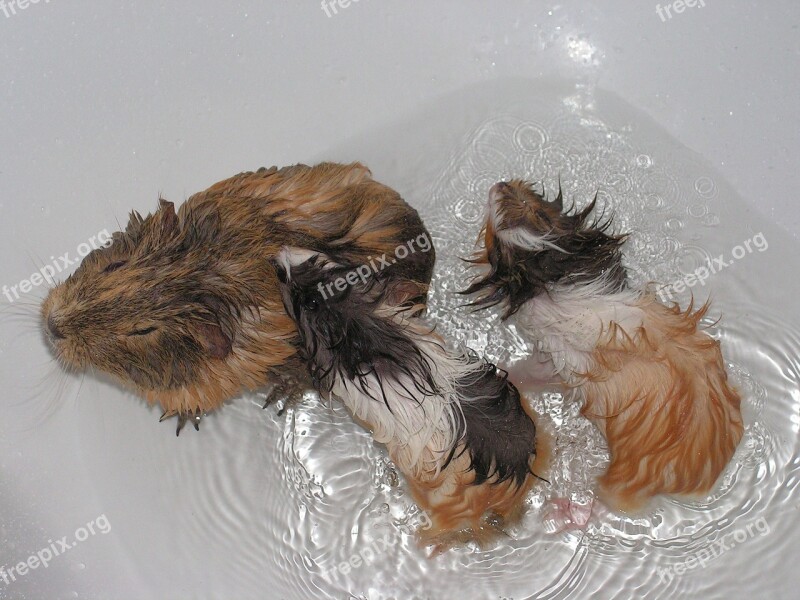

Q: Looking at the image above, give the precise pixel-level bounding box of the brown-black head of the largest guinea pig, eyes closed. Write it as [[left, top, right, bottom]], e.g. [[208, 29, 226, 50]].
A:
[[41, 200, 234, 391]]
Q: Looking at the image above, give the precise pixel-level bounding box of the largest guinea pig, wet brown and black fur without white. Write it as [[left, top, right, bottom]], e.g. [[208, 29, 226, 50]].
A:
[[41, 163, 435, 432]]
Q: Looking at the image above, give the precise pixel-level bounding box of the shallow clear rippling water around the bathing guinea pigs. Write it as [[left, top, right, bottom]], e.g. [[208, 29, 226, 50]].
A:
[[65, 81, 800, 600]]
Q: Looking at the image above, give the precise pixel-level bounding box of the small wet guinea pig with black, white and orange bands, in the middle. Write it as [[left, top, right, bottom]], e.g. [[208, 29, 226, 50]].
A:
[[276, 248, 546, 545]]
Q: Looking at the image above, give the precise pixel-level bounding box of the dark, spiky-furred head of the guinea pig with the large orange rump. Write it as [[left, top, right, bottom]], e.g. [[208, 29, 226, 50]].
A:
[[464, 179, 625, 318]]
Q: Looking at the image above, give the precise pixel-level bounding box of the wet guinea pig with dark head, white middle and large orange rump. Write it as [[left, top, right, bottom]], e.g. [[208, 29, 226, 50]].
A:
[[465, 180, 743, 511]]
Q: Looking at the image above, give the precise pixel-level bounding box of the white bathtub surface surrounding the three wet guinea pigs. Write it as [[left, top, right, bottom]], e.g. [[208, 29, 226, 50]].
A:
[[0, 0, 800, 600]]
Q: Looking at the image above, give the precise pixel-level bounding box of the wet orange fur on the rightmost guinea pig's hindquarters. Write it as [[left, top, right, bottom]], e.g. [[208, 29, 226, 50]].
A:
[[582, 296, 743, 510]]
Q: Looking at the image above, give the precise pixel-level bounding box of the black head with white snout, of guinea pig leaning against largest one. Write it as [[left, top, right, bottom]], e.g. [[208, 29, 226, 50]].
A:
[[275, 247, 429, 391]]
